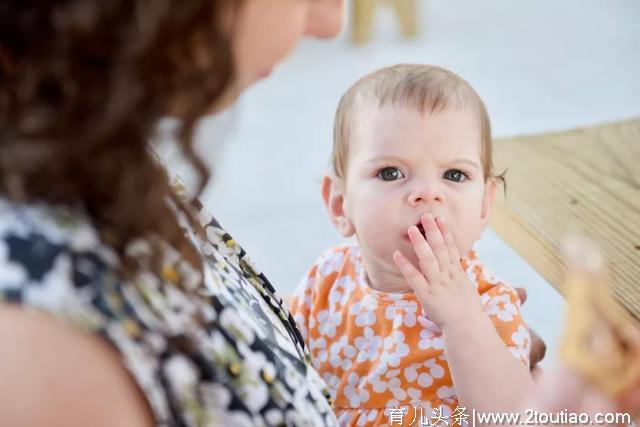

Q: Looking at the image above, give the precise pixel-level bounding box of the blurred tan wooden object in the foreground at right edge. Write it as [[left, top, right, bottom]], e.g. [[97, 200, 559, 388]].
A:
[[560, 240, 640, 400]]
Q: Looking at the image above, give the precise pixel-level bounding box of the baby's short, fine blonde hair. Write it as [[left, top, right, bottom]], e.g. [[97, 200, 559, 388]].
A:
[[331, 64, 503, 185]]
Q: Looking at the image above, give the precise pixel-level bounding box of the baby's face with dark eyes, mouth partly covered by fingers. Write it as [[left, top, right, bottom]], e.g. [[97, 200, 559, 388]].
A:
[[344, 106, 492, 276]]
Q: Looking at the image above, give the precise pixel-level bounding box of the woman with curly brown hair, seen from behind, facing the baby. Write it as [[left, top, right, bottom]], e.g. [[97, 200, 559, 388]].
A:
[[0, 0, 540, 426]]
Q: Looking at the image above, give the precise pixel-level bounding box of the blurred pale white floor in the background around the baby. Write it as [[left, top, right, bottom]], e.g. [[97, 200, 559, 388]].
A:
[[158, 0, 640, 368]]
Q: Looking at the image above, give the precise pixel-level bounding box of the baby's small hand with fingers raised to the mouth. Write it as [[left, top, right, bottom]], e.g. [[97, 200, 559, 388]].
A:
[[393, 214, 484, 328]]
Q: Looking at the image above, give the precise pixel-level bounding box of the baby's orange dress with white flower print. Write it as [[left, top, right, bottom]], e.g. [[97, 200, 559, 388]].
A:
[[291, 244, 531, 426]]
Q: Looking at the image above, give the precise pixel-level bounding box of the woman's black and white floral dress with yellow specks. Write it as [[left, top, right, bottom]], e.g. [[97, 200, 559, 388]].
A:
[[0, 181, 337, 426]]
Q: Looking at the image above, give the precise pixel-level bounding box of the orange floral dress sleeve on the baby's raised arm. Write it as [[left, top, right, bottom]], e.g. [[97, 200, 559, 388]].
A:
[[481, 283, 531, 367]]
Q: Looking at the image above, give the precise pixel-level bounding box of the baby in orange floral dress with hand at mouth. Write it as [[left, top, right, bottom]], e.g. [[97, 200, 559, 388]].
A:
[[292, 65, 533, 426]]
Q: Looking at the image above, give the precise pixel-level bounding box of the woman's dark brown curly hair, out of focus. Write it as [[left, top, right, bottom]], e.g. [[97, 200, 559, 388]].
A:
[[0, 0, 238, 278]]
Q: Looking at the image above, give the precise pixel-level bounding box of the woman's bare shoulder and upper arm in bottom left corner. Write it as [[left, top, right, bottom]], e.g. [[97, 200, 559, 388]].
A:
[[0, 304, 153, 426]]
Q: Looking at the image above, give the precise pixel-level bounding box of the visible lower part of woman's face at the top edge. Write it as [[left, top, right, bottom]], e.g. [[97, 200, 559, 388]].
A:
[[232, 0, 344, 91]]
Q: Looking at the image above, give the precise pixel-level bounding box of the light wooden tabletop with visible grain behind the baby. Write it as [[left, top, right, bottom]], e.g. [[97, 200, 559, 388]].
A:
[[491, 118, 640, 318]]
